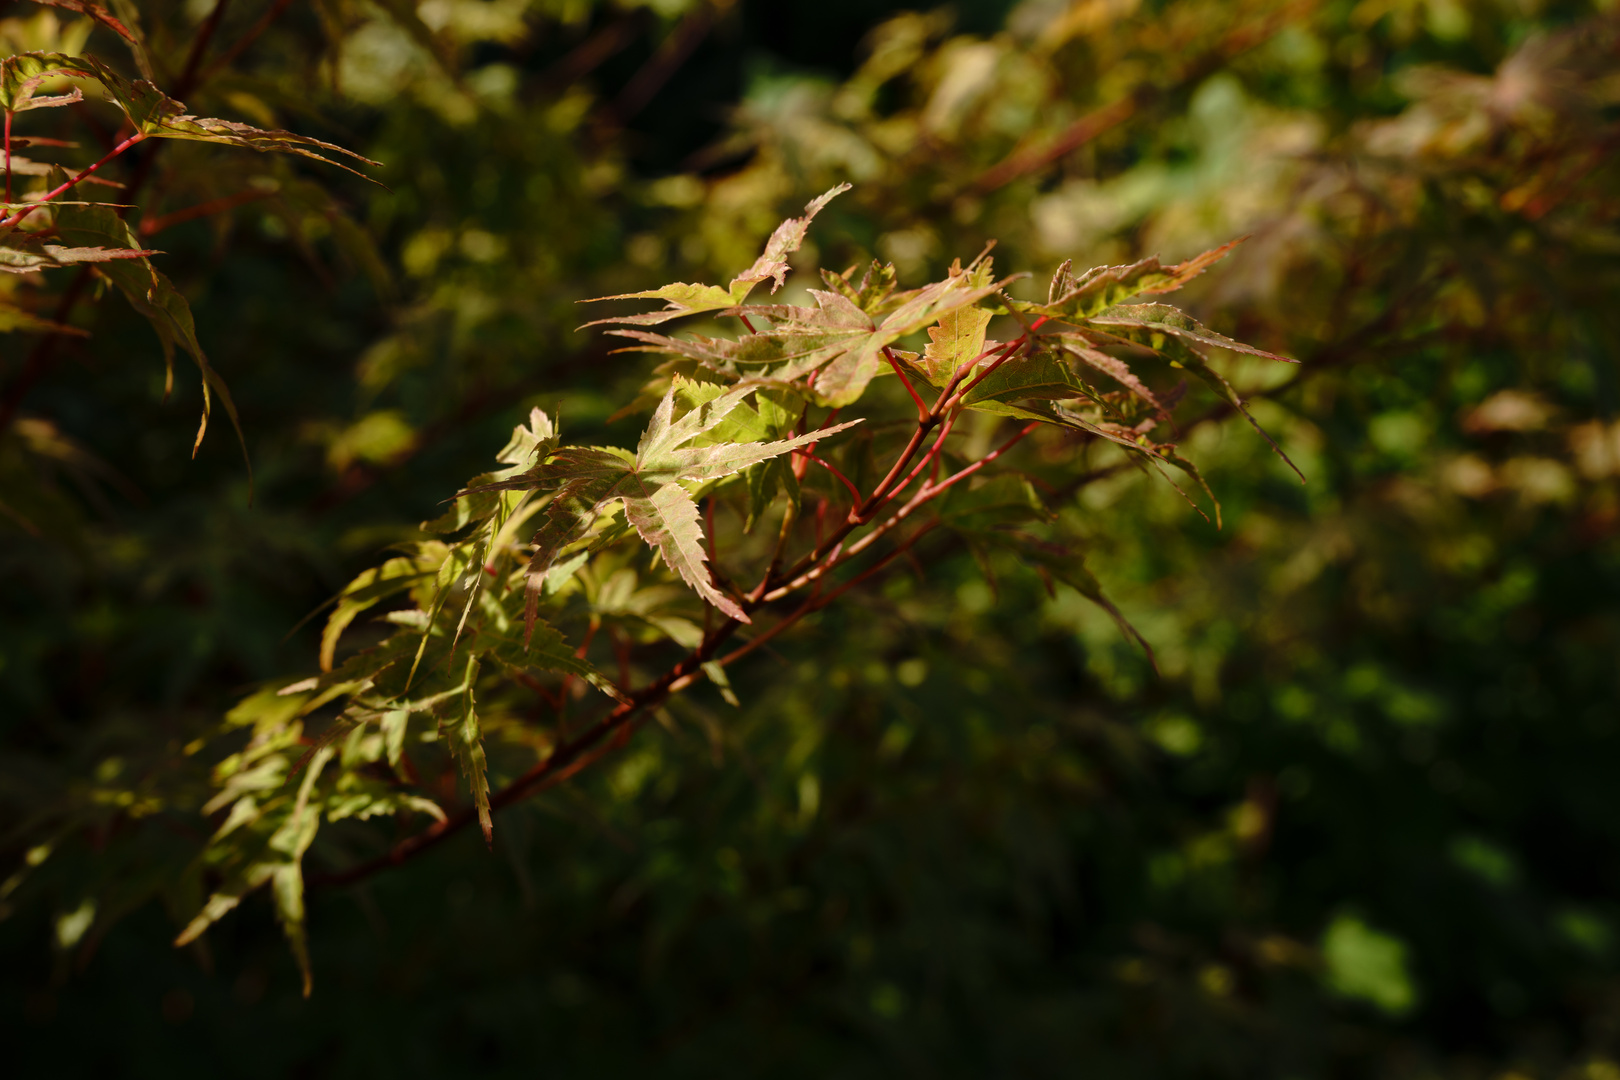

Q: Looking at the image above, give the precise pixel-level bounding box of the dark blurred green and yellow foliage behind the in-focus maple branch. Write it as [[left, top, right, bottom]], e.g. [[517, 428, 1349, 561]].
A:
[[0, 0, 1620, 1080]]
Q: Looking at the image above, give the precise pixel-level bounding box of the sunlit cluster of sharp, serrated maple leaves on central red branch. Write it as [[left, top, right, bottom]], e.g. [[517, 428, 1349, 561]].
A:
[[161, 188, 1285, 993]]
